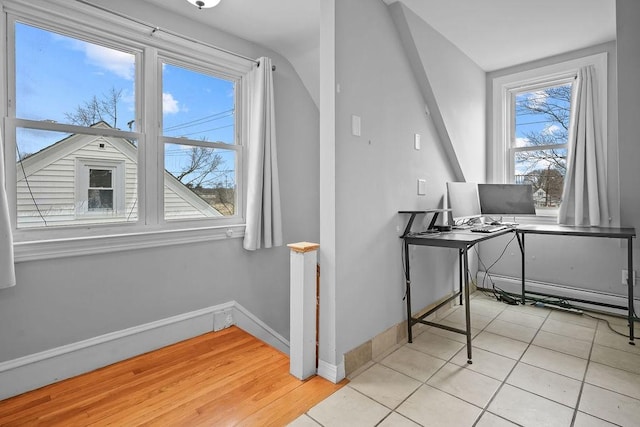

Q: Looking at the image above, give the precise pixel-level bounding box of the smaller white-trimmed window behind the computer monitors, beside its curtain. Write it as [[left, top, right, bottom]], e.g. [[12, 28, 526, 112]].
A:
[[489, 53, 607, 216]]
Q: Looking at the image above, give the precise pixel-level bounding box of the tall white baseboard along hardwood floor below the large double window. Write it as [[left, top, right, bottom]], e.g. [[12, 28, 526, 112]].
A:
[[0, 301, 289, 400]]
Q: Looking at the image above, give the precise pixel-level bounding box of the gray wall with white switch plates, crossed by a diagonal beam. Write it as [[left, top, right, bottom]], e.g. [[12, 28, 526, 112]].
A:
[[330, 0, 485, 363]]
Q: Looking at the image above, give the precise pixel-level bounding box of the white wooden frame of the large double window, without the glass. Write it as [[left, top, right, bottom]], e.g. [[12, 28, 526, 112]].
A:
[[0, 0, 254, 262]]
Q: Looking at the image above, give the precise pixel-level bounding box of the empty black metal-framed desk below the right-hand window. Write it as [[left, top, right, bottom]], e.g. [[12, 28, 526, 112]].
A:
[[516, 224, 639, 345]]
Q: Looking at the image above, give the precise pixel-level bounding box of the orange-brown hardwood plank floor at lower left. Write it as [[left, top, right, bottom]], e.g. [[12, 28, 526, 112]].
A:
[[0, 326, 346, 427]]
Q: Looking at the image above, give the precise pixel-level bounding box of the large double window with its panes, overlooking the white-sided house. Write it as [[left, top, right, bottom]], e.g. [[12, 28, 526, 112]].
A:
[[3, 2, 252, 255]]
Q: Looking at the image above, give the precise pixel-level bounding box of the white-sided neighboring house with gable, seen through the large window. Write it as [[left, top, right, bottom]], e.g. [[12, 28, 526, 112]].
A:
[[17, 122, 222, 227]]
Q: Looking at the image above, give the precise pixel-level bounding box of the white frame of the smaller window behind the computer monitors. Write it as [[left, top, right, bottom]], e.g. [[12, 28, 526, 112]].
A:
[[487, 52, 608, 222]]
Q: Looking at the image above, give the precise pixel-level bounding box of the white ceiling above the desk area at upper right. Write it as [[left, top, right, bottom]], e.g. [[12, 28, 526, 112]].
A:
[[384, 0, 616, 71]]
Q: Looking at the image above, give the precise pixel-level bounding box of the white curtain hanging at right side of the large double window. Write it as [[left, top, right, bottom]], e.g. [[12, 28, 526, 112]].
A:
[[243, 57, 282, 250]]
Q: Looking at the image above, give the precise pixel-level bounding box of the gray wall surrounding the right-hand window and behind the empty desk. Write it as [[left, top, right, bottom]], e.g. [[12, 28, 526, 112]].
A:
[[480, 42, 631, 295]]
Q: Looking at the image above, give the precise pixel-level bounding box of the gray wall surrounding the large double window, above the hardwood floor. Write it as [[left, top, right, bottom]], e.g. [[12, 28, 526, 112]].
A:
[[0, 0, 319, 361]]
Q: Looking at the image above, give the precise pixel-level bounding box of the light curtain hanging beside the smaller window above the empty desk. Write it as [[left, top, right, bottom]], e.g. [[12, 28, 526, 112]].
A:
[[558, 65, 609, 226]]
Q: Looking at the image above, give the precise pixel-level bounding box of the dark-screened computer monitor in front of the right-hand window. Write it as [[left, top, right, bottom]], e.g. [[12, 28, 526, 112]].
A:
[[478, 184, 536, 216]]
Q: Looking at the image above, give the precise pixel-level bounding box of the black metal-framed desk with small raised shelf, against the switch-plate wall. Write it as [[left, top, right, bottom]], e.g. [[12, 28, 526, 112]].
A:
[[399, 211, 513, 364]]
